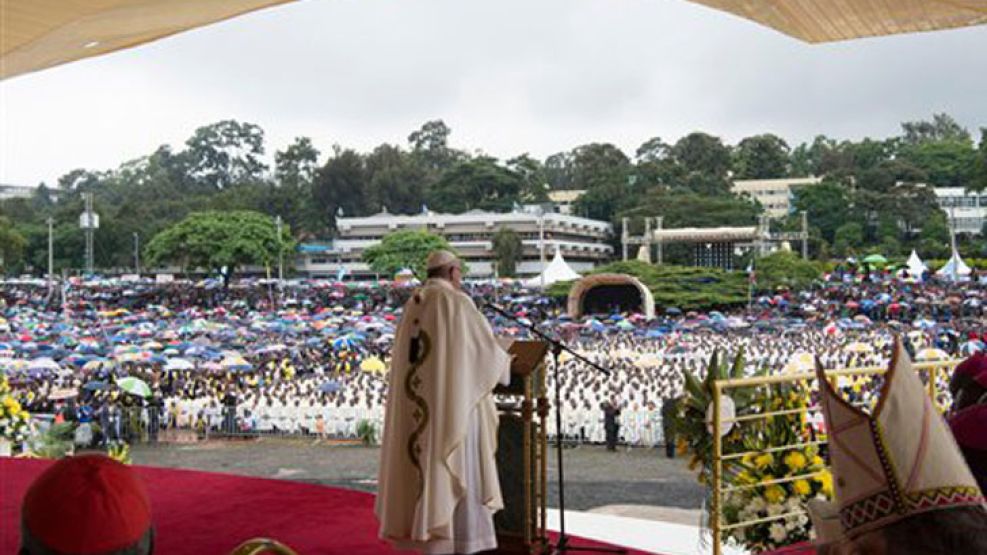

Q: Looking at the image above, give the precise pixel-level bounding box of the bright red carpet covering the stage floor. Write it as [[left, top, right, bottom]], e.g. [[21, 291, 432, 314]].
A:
[[0, 457, 656, 555]]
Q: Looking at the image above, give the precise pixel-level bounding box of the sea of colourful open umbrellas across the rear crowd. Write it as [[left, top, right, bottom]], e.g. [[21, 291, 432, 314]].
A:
[[0, 276, 985, 406]]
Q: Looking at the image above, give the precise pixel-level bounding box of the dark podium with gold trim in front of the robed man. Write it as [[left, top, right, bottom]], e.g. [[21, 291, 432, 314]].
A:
[[491, 338, 549, 555]]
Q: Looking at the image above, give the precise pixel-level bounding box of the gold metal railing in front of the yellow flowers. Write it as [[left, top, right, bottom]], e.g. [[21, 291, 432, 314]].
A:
[[710, 360, 960, 555]]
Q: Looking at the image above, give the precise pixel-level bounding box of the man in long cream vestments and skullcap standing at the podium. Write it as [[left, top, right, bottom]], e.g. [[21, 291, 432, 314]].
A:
[[375, 251, 511, 554]]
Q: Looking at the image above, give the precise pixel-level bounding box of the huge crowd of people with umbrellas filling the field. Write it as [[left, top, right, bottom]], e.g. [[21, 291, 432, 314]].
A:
[[0, 273, 987, 452]]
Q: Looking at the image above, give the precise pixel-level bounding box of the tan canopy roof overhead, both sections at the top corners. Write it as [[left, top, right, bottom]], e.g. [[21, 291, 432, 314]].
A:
[[0, 0, 987, 79]]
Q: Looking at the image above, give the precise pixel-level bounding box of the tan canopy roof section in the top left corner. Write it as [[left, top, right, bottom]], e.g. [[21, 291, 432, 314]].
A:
[[0, 0, 292, 79]]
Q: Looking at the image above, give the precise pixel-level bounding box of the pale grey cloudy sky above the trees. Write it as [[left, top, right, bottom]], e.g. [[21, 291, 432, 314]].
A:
[[0, 0, 987, 185]]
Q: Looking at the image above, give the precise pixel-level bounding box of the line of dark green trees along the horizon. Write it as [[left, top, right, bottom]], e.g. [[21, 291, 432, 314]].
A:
[[0, 114, 987, 273]]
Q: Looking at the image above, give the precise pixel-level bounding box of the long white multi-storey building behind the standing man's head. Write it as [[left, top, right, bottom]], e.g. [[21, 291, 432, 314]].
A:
[[297, 207, 613, 277]]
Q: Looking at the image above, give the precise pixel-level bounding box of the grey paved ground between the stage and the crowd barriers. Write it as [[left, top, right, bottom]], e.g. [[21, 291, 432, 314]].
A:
[[132, 439, 702, 524]]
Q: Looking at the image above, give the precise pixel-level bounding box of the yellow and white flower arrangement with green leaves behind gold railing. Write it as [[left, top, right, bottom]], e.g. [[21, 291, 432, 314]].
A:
[[674, 353, 833, 552]]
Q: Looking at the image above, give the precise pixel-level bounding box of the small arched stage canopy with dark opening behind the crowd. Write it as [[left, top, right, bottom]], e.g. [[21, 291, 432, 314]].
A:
[[567, 274, 655, 318]]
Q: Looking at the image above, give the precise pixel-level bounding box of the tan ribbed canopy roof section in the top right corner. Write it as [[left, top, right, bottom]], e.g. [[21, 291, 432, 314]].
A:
[[692, 0, 987, 42]]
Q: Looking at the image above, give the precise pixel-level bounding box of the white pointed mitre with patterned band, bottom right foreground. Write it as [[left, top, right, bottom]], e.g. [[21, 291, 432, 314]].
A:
[[816, 341, 984, 539]]
